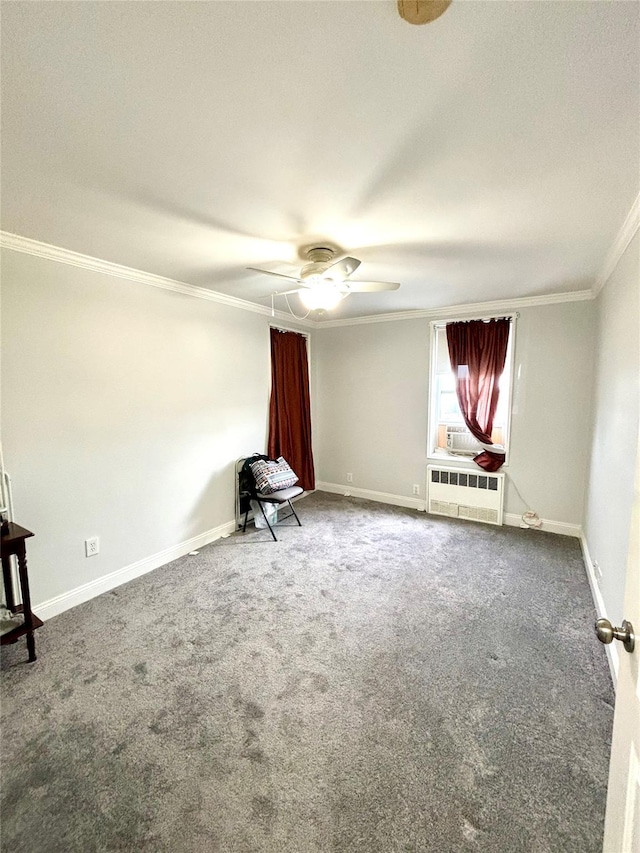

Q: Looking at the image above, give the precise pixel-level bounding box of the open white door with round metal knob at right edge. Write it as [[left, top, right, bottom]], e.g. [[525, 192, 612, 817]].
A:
[[604, 436, 640, 853]]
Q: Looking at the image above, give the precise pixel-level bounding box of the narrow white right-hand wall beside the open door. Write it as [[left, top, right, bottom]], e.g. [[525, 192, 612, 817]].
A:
[[584, 233, 640, 624]]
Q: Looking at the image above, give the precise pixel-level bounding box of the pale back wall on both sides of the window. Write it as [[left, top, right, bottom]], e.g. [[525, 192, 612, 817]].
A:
[[314, 302, 594, 527]]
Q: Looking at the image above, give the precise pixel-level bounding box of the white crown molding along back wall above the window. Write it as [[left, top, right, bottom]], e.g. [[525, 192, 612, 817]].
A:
[[316, 290, 593, 329]]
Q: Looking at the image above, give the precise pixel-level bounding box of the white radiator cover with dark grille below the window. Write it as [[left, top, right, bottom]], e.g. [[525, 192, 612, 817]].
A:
[[427, 465, 504, 524]]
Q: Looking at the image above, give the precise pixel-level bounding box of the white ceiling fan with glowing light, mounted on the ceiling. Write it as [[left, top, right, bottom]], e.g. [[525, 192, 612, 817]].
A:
[[247, 245, 400, 311]]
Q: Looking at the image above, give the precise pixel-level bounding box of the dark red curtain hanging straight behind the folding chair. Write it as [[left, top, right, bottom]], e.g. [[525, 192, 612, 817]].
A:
[[267, 329, 316, 490]]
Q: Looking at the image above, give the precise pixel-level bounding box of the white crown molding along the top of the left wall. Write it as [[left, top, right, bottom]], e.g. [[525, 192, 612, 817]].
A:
[[0, 231, 318, 328]]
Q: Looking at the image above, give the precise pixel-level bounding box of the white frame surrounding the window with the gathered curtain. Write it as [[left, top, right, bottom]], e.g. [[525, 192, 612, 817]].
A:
[[427, 312, 520, 468]]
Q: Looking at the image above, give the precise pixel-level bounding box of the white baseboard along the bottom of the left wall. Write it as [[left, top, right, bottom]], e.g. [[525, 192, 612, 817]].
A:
[[33, 520, 236, 621]]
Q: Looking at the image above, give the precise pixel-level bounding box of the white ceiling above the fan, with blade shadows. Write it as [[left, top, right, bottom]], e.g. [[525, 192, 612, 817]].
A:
[[2, 0, 640, 318]]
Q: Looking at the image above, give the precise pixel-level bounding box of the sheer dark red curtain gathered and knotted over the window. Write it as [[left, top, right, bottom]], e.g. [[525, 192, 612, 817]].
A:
[[447, 319, 510, 471]]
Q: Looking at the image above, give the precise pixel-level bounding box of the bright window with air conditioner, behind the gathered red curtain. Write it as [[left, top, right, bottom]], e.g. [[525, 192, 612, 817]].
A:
[[428, 317, 515, 459]]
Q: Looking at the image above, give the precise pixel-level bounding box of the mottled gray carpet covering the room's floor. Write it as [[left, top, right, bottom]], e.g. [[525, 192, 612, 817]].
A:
[[2, 493, 613, 853]]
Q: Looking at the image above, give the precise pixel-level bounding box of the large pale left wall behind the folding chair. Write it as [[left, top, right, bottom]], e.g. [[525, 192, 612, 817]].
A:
[[2, 251, 308, 612]]
